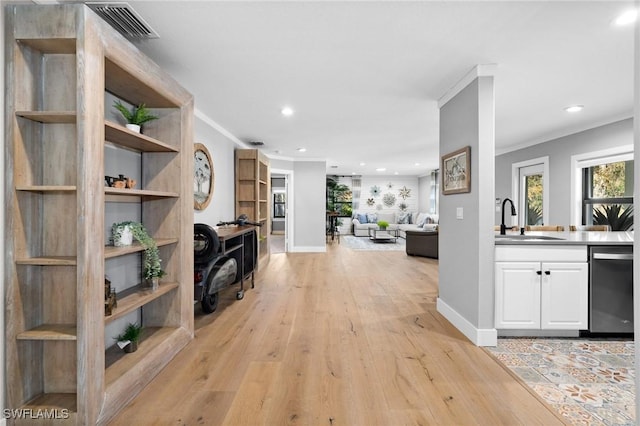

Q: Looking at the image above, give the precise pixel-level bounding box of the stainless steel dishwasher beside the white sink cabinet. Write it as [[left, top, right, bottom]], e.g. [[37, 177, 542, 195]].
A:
[[589, 245, 633, 334]]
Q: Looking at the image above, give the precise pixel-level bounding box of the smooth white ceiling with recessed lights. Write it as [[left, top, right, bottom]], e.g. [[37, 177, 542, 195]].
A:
[[117, 0, 633, 175]]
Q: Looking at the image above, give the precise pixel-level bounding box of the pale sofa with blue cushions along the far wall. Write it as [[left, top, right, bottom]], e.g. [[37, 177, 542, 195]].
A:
[[352, 212, 438, 238]]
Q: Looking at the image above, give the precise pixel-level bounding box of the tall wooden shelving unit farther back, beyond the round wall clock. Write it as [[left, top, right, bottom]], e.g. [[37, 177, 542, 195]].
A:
[[235, 149, 271, 267]]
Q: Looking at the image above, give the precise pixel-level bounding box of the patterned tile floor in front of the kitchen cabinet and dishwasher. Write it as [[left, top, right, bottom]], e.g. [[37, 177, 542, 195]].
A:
[[486, 338, 635, 425]]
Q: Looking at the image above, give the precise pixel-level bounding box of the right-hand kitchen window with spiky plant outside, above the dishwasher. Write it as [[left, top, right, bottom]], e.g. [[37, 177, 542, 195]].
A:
[[582, 160, 633, 231]]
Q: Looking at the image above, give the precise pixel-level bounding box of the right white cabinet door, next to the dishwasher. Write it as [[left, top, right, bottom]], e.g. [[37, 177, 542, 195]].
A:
[[540, 262, 589, 330]]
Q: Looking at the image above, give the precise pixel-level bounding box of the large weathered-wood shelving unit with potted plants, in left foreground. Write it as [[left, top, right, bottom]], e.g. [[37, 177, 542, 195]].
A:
[[3, 4, 193, 425]]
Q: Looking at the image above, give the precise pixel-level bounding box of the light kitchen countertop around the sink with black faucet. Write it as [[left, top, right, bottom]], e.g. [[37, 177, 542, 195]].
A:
[[495, 231, 633, 245]]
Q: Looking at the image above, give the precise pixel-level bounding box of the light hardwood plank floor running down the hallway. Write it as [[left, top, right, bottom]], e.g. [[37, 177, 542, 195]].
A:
[[112, 243, 564, 426]]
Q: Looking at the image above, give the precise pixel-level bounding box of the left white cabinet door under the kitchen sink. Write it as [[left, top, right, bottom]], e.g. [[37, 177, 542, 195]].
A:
[[495, 262, 540, 329]]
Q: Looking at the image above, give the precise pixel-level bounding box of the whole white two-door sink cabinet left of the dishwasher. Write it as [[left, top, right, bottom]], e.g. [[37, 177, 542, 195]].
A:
[[495, 246, 589, 330]]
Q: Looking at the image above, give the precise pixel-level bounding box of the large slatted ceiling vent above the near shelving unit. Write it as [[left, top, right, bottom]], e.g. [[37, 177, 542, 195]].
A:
[[86, 2, 160, 39]]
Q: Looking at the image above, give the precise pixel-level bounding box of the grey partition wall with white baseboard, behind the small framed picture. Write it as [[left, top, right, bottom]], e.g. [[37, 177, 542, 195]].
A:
[[438, 76, 497, 345]]
